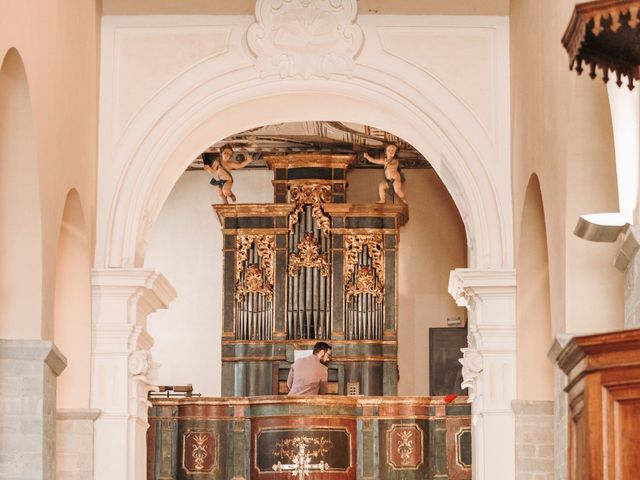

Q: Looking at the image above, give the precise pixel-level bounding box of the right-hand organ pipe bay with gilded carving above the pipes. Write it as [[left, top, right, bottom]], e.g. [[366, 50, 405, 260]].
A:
[[344, 234, 385, 340]]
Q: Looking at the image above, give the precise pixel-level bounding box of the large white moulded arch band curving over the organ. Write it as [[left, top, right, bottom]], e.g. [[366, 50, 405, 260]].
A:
[[96, 69, 513, 274]]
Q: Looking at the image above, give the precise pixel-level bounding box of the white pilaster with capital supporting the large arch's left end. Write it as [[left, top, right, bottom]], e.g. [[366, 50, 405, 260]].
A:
[[91, 269, 176, 480]]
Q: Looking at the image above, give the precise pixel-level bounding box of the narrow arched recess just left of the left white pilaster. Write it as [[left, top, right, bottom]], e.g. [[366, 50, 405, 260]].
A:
[[53, 189, 92, 408]]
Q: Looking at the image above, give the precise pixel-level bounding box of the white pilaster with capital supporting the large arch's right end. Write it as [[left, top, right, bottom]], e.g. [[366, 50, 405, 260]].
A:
[[449, 268, 516, 480]]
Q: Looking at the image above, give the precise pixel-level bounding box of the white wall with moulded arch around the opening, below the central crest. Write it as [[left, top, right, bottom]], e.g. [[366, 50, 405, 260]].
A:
[[96, 15, 513, 268]]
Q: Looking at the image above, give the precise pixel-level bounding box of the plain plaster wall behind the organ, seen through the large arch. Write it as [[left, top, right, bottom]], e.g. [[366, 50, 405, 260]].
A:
[[147, 170, 466, 395]]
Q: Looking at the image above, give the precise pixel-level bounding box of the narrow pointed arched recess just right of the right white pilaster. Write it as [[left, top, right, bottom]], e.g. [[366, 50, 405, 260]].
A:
[[516, 173, 554, 400]]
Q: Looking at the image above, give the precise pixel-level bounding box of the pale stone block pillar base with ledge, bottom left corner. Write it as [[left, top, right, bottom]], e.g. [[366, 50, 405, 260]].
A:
[[0, 340, 67, 480]]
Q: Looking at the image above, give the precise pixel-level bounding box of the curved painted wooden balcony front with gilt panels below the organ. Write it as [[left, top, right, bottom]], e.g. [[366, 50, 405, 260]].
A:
[[147, 396, 471, 480]]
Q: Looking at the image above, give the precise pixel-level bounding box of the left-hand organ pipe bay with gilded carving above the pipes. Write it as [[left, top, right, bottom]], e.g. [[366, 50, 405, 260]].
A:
[[234, 235, 275, 340]]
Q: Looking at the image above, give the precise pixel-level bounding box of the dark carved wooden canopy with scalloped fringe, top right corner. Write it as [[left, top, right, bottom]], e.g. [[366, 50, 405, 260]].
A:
[[562, 0, 640, 90]]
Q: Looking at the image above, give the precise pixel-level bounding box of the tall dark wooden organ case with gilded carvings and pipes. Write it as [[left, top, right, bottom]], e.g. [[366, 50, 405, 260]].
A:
[[213, 154, 408, 397]]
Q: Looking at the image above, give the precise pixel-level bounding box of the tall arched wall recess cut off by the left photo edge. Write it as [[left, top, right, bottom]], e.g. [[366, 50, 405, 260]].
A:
[[0, 48, 43, 339]]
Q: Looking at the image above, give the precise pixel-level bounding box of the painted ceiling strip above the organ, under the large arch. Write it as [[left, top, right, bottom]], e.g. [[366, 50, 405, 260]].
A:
[[188, 121, 431, 170]]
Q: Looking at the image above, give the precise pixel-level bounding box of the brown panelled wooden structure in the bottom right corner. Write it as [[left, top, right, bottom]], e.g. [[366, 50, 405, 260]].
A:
[[557, 330, 640, 480]]
